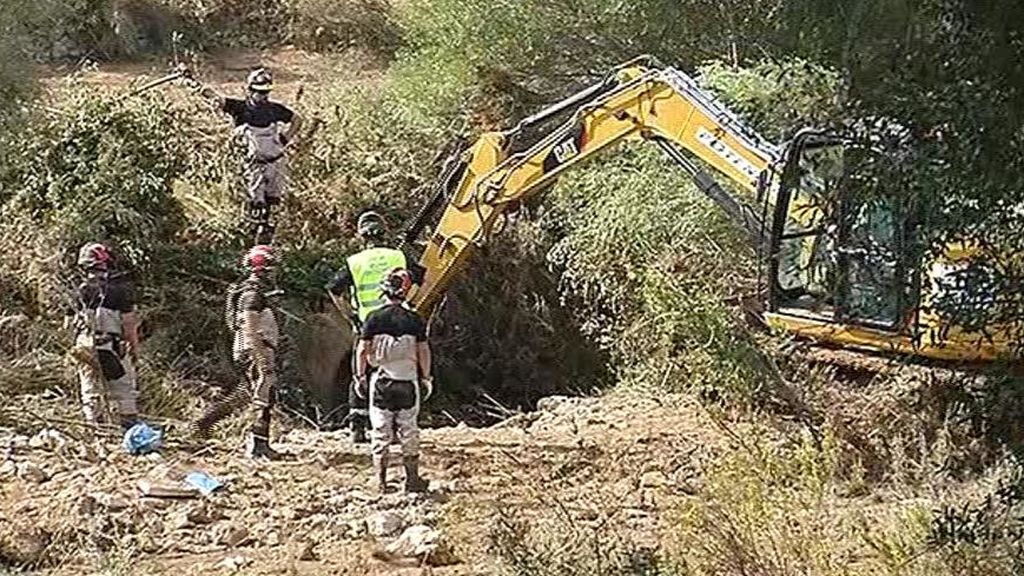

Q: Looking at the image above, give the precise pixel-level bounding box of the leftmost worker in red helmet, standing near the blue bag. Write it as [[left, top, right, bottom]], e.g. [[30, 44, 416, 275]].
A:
[[66, 242, 138, 429]]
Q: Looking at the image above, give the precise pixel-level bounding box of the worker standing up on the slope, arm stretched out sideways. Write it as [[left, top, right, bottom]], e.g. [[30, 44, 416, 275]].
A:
[[189, 68, 302, 242]]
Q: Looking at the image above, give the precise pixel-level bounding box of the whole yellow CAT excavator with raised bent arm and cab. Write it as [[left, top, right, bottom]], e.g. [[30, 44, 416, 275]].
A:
[[402, 57, 1020, 361]]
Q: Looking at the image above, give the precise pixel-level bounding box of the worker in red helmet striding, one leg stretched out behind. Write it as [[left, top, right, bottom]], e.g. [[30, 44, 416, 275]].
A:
[[194, 245, 280, 459]]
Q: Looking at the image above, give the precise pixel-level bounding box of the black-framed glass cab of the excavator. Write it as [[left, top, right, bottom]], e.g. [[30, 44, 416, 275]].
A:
[[771, 133, 908, 330]]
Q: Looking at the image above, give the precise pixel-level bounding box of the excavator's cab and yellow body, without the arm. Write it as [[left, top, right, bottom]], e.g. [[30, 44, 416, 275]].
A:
[[759, 130, 1012, 361]]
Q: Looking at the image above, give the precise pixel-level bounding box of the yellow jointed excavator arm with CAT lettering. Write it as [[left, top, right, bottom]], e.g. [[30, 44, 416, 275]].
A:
[[406, 58, 780, 317]]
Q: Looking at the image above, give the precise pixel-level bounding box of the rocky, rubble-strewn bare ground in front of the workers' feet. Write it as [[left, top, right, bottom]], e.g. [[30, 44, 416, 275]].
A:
[[0, 393, 728, 575]]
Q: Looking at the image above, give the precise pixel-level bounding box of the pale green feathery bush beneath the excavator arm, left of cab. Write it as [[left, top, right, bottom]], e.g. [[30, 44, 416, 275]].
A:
[[543, 146, 759, 399]]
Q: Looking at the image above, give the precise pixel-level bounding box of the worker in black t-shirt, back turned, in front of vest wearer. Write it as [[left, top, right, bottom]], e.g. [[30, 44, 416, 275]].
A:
[[355, 269, 433, 492]]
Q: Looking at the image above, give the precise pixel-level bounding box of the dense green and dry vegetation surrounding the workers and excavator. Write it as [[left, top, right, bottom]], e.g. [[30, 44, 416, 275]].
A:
[[0, 0, 1024, 575]]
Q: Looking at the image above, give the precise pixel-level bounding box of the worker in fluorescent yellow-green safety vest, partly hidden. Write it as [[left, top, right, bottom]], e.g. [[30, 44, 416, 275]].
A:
[[327, 210, 424, 444]]
